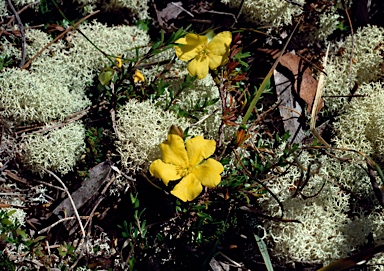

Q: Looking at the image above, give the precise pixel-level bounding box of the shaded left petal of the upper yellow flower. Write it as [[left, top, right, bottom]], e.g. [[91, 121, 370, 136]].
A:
[[174, 34, 208, 61]]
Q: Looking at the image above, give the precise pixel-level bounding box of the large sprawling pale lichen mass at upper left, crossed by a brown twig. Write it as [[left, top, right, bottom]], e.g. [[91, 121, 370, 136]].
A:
[[0, 22, 149, 123]]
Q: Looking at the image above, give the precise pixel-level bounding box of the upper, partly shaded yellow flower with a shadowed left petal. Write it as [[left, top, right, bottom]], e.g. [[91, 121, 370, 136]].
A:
[[175, 31, 232, 79]]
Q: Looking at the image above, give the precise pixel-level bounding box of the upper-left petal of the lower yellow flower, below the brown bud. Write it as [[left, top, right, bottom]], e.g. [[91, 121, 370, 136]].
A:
[[160, 134, 189, 168]]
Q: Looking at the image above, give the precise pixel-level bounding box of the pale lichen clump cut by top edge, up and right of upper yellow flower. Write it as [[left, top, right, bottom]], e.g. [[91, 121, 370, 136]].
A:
[[221, 0, 305, 27]]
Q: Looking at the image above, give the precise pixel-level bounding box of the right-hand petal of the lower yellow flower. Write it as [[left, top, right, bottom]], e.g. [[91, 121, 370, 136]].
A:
[[191, 158, 224, 188]]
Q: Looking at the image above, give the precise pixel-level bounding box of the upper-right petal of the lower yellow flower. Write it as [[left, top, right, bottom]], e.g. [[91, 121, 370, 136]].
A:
[[185, 136, 216, 167]]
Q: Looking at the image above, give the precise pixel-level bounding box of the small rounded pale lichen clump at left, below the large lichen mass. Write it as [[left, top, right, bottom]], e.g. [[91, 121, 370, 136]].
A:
[[22, 122, 85, 175]]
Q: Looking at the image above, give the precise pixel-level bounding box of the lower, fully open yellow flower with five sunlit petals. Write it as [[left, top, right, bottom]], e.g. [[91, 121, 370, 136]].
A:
[[149, 134, 224, 202]]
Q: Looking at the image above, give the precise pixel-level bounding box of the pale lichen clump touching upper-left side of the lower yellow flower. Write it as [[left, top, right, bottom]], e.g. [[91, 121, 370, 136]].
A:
[[116, 100, 202, 173]]
